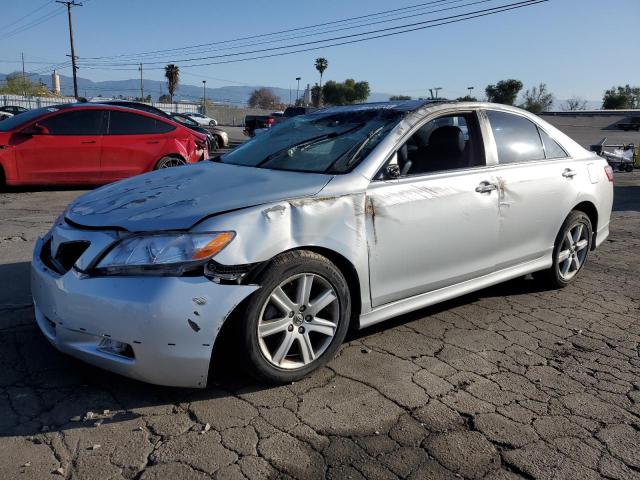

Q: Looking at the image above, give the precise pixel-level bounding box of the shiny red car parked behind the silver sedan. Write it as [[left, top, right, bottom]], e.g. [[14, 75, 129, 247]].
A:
[[0, 103, 208, 185]]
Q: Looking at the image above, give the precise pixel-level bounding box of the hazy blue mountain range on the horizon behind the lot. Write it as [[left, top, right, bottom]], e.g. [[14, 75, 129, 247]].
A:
[[0, 73, 390, 105]]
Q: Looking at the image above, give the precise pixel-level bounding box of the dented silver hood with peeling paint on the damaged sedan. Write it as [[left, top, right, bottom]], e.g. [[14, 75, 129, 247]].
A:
[[66, 162, 332, 231]]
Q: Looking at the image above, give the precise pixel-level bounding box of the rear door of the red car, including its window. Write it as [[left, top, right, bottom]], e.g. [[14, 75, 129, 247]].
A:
[[101, 110, 175, 182]]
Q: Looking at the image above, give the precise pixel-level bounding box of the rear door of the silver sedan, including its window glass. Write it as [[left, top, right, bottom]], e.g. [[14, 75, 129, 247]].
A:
[[486, 110, 585, 269]]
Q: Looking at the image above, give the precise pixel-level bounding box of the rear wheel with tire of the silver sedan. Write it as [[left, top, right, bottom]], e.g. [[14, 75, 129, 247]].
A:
[[534, 210, 593, 288]]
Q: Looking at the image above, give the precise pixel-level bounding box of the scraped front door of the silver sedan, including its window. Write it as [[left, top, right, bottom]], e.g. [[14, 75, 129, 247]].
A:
[[366, 111, 498, 308]]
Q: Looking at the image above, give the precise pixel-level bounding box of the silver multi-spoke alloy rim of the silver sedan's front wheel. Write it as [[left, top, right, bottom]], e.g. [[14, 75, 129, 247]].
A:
[[258, 273, 340, 370]]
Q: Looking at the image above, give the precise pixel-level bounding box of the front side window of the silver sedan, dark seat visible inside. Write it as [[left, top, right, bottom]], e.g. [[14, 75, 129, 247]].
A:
[[397, 113, 485, 176]]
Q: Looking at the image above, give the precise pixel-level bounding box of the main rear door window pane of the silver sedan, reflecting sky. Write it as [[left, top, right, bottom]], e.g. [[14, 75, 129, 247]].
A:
[[487, 110, 545, 163]]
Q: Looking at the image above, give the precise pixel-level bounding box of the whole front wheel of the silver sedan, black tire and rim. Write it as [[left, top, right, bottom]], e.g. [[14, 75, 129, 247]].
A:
[[238, 250, 351, 383]]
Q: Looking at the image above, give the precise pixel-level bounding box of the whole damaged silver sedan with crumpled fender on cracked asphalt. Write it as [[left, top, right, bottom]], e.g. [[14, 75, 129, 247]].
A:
[[31, 101, 613, 387]]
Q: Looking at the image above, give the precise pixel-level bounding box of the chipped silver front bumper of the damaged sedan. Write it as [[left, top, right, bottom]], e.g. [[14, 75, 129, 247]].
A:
[[31, 234, 259, 388]]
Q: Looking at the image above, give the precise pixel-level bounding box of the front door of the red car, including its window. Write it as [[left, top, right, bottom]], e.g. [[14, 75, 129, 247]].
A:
[[15, 109, 104, 184]]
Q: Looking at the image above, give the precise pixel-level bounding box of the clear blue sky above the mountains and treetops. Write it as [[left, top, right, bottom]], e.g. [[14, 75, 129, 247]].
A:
[[0, 0, 640, 100]]
